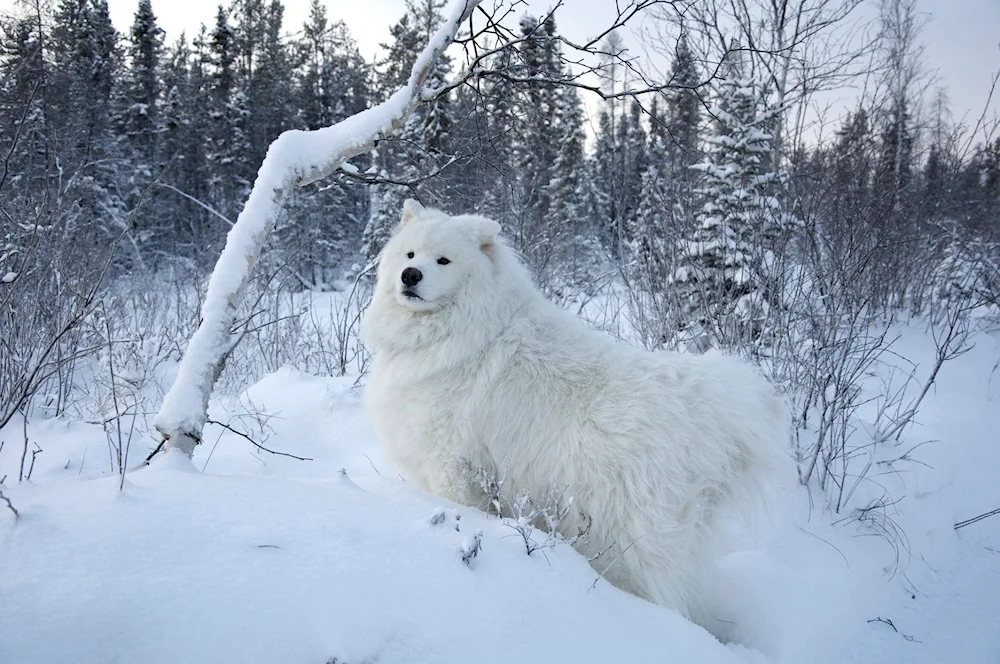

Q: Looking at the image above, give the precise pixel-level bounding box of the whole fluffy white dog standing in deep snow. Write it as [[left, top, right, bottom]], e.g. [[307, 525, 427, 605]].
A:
[[363, 201, 786, 616]]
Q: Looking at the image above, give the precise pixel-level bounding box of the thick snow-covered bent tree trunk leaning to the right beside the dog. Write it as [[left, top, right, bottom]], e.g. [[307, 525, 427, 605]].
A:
[[153, 0, 481, 456]]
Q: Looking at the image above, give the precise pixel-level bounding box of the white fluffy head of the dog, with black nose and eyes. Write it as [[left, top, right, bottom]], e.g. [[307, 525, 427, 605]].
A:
[[378, 199, 500, 312]]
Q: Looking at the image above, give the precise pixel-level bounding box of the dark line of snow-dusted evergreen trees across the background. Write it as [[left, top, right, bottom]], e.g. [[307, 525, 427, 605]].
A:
[[0, 0, 1000, 290]]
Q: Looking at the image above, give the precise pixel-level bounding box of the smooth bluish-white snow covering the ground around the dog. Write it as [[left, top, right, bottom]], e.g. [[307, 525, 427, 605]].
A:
[[0, 308, 1000, 664]]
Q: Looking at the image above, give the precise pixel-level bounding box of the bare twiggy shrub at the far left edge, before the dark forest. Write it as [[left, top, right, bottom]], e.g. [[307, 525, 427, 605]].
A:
[[0, 171, 156, 452]]
